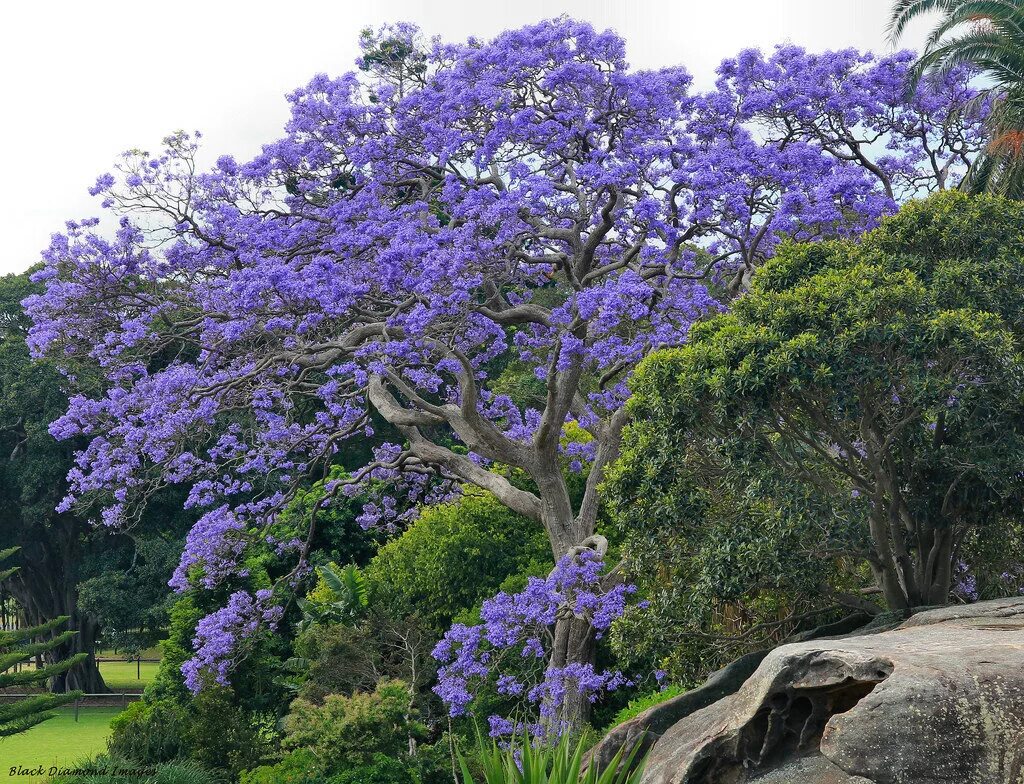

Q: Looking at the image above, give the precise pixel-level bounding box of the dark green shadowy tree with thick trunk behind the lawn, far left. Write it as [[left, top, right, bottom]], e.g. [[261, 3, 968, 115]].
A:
[[0, 274, 191, 693]]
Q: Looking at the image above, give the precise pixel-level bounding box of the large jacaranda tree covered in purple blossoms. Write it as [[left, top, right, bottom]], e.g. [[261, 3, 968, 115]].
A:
[[27, 18, 977, 728]]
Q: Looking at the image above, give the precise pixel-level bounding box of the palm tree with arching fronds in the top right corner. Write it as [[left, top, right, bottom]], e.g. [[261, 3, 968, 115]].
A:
[[889, 0, 1024, 200]]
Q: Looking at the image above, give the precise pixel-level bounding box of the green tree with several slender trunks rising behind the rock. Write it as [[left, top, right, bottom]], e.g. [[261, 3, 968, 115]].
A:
[[617, 192, 1024, 608]]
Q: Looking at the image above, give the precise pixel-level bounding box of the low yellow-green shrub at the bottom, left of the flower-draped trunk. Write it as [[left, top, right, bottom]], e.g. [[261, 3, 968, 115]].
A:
[[284, 681, 424, 773]]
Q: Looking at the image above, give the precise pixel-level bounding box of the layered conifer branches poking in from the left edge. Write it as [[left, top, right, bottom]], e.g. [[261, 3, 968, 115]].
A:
[[0, 548, 86, 738]]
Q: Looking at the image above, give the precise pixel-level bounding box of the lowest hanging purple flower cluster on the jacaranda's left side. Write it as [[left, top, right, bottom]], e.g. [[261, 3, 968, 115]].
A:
[[181, 590, 283, 694]]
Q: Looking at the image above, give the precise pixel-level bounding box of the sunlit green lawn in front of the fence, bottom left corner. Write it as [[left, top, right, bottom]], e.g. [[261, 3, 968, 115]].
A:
[[0, 708, 123, 782]]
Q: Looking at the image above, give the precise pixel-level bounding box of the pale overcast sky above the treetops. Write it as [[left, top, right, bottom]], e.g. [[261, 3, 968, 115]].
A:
[[0, 0, 927, 273]]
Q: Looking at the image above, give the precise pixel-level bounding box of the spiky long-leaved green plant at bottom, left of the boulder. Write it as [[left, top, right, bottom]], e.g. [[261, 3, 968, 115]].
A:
[[457, 737, 644, 784]]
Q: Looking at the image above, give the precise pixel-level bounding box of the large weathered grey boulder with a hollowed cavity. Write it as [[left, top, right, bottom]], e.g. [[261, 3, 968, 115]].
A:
[[642, 599, 1024, 784]]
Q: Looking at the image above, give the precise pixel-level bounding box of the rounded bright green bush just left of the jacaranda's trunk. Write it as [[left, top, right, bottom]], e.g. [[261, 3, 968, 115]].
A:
[[366, 488, 551, 634]]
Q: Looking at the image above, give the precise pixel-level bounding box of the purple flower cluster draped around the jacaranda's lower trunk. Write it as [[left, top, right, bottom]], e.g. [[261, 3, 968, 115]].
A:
[[433, 551, 636, 736]]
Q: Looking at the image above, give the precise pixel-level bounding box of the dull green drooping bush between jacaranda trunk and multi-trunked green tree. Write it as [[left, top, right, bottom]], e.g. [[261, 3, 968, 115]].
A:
[[607, 462, 868, 684]]
